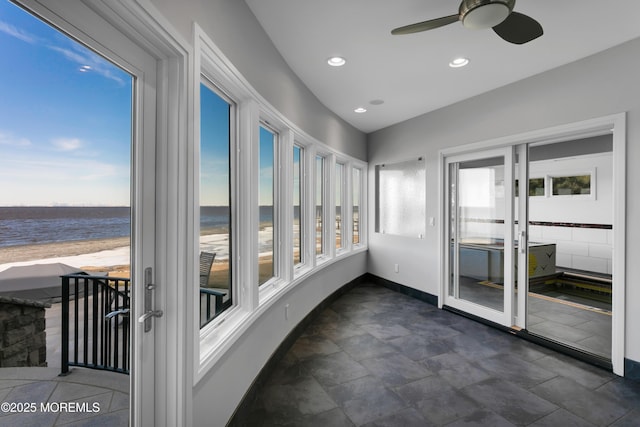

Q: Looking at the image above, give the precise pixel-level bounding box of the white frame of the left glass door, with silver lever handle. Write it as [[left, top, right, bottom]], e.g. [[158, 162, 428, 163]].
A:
[[19, 0, 172, 426]]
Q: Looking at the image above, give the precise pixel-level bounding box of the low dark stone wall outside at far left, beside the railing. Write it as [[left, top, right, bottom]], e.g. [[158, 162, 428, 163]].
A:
[[0, 297, 51, 368]]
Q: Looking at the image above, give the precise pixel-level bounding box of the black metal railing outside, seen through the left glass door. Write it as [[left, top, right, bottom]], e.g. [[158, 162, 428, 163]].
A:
[[60, 274, 131, 375]]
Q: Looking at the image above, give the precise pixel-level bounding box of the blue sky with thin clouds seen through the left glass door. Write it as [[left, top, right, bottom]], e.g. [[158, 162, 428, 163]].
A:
[[0, 0, 133, 206]]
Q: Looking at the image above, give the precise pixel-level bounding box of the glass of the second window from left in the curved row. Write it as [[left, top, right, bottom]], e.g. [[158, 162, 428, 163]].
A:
[[258, 124, 277, 285]]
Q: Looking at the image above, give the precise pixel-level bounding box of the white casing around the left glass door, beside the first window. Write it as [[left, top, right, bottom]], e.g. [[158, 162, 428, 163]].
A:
[[13, 0, 193, 426]]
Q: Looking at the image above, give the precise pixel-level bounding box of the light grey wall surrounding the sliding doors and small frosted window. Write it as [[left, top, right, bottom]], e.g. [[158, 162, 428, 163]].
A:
[[368, 39, 640, 361]]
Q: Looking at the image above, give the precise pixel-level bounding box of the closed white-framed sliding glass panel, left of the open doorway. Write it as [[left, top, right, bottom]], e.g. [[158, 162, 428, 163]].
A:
[[444, 147, 515, 326]]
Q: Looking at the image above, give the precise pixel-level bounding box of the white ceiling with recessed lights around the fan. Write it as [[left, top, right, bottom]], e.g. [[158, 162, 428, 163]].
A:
[[245, 0, 640, 132]]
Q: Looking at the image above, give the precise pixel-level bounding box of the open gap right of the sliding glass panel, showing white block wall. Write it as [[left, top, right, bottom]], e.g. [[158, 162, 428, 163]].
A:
[[523, 133, 615, 360]]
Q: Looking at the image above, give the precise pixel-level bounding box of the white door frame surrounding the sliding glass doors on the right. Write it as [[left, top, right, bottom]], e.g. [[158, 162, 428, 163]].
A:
[[438, 112, 626, 376]]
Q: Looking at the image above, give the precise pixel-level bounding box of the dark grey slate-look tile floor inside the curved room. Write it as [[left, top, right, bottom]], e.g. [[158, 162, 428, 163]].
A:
[[246, 285, 640, 427]]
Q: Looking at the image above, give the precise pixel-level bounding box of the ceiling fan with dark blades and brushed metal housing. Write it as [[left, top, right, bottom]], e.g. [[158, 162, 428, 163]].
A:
[[391, 0, 543, 44]]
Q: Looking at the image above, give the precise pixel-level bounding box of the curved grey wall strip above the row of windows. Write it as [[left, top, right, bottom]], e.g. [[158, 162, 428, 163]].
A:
[[151, 0, 367, 160]]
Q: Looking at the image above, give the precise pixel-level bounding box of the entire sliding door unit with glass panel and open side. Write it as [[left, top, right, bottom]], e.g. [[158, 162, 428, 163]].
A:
[[442, 116, 625, 375]]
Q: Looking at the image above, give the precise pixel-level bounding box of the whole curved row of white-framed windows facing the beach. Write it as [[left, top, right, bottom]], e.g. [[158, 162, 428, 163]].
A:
[[194, 25, 367, 381]]
